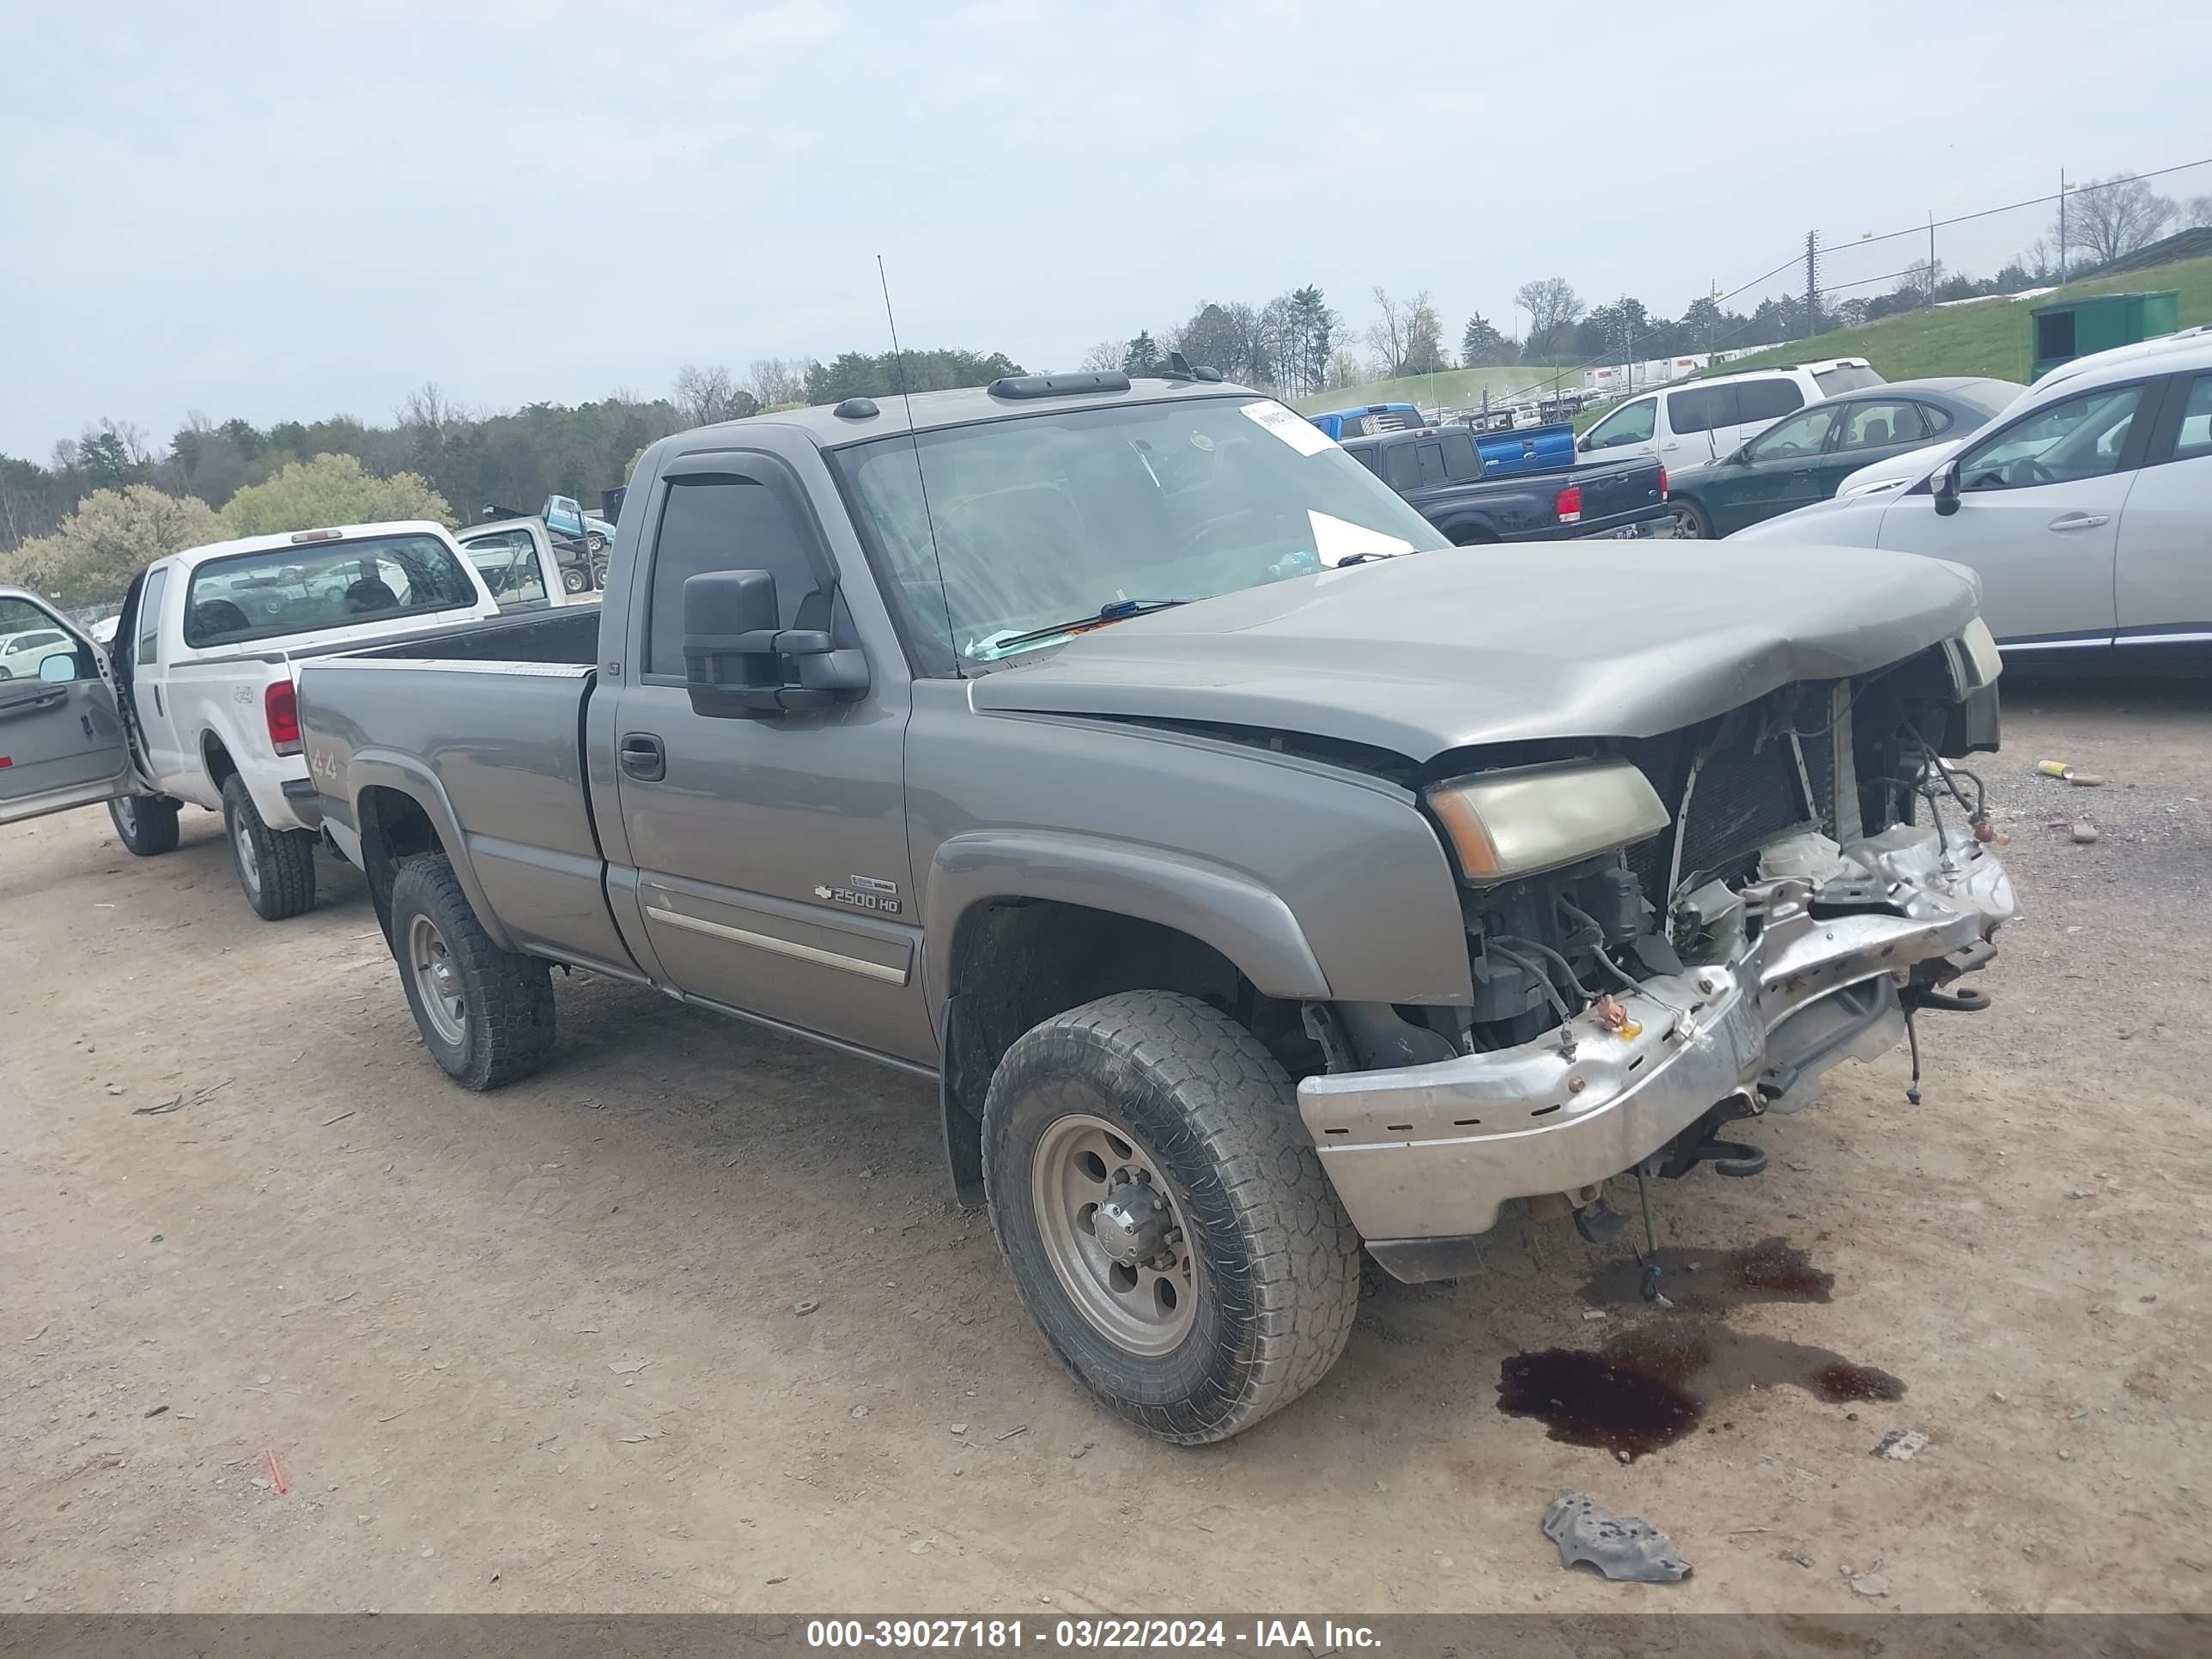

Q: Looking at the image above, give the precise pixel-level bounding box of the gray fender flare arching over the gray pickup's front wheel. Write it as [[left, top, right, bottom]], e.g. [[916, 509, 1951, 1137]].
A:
[[922, 830, 1329, 1036]]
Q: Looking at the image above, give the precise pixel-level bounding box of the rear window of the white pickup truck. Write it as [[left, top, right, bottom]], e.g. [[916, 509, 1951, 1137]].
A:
[[184, 535, 476, 646]]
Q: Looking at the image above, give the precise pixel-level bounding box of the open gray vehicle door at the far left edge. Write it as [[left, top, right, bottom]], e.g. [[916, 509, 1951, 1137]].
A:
[[0, 588, 137, 823]]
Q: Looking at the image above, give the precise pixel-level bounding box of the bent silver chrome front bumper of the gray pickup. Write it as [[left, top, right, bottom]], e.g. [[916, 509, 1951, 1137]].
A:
[[1298, 825, 2015, 1243]]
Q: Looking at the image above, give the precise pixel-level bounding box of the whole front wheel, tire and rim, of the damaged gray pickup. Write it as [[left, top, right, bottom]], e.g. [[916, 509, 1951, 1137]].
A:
[[982, 991, 1360, 1444]]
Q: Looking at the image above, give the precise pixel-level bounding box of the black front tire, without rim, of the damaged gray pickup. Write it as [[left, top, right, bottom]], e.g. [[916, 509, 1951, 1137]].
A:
[[982, 991, 1360, 1444]]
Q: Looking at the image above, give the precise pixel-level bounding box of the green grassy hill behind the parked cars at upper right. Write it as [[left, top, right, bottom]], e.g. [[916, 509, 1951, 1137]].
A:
[[1712, 258, 2212, 383]]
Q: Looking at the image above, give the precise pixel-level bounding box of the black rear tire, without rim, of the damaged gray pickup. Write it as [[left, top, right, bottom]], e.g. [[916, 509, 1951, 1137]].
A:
[[389, 854, 553, 1091]]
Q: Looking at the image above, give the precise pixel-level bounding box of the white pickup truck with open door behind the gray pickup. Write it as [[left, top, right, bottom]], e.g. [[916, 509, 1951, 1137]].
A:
[[0, 520, 500, 922]]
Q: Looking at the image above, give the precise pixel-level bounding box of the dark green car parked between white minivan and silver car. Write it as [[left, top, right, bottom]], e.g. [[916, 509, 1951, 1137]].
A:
[[1668, 376, 2024, 540]]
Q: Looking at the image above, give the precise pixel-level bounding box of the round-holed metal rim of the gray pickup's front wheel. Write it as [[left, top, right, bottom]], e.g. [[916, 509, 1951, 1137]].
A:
[[1029, 1113, 1201, 1354]]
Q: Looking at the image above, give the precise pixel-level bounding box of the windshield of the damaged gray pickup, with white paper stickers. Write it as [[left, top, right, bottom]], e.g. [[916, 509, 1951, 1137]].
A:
[[832, 398, 1444, 672]]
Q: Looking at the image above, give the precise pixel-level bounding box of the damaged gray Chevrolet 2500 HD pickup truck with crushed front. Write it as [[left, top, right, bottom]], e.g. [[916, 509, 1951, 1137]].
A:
[[299, 369, 2013, 1443]]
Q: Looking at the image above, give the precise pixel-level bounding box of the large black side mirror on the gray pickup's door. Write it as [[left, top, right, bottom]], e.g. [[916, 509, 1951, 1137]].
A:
[[684, 571, 867, 719]]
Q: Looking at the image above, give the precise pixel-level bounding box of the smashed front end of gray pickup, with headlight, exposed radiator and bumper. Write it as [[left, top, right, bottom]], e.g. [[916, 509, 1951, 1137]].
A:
[[1298, 633, 2015, 1281]]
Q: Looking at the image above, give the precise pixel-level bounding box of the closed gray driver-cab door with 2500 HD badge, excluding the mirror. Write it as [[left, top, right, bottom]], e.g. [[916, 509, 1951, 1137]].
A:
[[592, 449, 936, 1061]]
